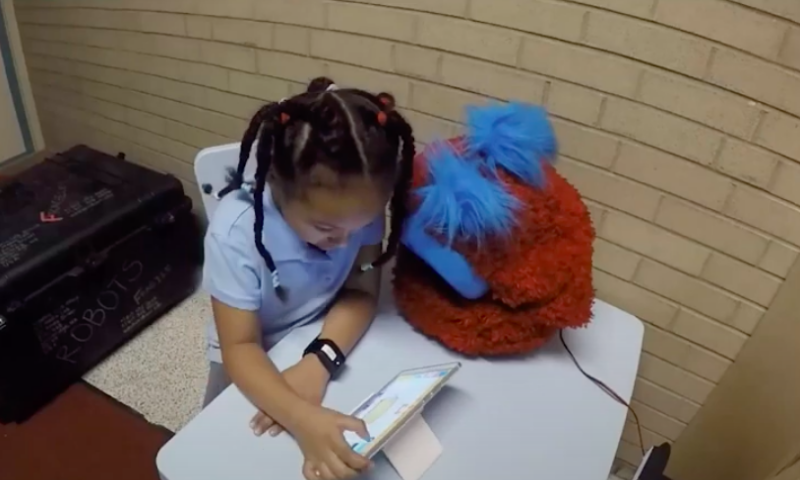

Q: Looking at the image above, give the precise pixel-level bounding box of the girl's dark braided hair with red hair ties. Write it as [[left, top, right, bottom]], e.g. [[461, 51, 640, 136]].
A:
[[219, 77, 415, 297]]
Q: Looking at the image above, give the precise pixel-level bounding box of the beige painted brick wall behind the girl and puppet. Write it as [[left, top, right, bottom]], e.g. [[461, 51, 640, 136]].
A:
[[10, 0, 800, 472]]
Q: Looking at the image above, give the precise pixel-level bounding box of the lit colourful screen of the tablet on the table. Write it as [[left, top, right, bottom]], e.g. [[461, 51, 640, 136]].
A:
[[344, 365, 453, 453]]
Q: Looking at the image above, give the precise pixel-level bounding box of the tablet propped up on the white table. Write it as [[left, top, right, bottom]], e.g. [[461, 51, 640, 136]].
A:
[[344, 362, 461, 458]]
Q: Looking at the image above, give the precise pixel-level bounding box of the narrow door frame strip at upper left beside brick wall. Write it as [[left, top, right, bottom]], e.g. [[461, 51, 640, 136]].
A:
[[0, 0, 44, 166]]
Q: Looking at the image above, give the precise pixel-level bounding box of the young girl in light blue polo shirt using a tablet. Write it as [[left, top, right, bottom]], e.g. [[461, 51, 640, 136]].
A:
[[204, 78, 414, 480]]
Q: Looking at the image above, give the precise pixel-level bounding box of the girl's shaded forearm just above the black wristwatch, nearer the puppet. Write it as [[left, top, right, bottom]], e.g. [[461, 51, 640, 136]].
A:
[[320, 244, 381, 354]]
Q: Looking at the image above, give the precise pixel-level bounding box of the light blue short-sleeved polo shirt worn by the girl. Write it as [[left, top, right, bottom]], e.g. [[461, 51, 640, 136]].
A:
[[203, 186, 385, 362]]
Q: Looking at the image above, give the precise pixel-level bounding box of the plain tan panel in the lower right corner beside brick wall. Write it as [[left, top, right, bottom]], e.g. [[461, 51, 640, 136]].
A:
[[667, 255, 800, 480]]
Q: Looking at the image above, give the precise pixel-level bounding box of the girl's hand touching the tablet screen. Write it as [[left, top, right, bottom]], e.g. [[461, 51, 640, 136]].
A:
[[291, 408, 370, 480]]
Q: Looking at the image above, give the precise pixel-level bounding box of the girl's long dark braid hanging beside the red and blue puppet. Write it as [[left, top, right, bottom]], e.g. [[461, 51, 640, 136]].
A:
[[372, 111, 416, 268]]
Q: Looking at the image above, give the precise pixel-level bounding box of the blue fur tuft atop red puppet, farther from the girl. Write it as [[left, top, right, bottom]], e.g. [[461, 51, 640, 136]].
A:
[[466, 102, 558, 187]]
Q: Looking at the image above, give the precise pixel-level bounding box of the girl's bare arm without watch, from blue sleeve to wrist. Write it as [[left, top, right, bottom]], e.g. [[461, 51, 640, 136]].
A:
[[211, 297, 318, 430]]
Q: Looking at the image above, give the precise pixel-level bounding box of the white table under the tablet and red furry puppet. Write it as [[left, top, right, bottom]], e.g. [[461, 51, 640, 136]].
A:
[[157, 301, 643, 480]]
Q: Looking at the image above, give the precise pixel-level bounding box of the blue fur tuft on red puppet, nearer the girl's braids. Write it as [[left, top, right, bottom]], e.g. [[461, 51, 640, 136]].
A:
[[412, 144, 519, 245]]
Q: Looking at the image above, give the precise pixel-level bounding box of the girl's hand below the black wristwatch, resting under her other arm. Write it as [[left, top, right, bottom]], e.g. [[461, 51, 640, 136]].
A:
[[250, 355, 330, 437]]
